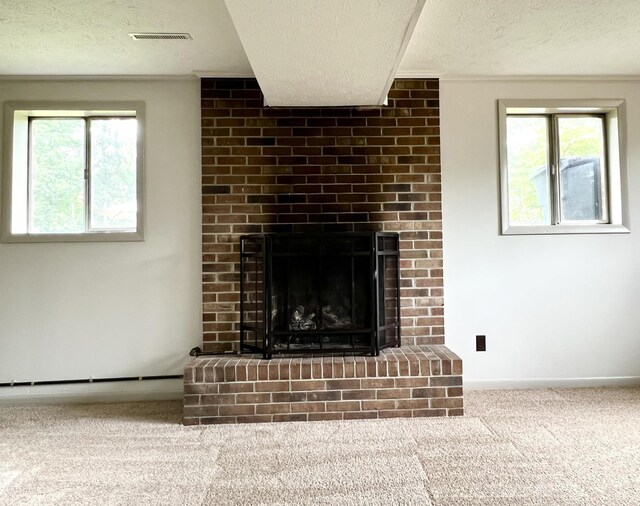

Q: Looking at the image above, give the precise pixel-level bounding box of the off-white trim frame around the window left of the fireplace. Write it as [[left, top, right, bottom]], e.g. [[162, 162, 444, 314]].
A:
[[0, 101, 145, 243]]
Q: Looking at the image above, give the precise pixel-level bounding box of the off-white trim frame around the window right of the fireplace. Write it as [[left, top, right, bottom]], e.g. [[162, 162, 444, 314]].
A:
[[498, 99, 629, 235]]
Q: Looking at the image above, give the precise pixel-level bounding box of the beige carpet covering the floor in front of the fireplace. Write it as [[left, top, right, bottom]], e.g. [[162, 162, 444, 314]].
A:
[[0, 388, 640, 506]]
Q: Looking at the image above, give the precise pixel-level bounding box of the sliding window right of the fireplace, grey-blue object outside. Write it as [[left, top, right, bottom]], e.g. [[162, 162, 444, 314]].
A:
[[498, 100, 629, 234]]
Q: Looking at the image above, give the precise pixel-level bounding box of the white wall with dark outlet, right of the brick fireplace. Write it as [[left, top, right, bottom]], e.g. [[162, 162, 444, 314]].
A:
[[441, 80, 640, 386]]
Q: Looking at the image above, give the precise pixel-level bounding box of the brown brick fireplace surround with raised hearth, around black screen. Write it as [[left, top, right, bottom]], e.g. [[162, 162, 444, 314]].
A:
[[184, 79, 462, 424]]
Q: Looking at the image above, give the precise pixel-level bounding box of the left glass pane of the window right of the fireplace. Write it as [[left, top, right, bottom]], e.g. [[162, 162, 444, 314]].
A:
[[507, 116, 551, 225]]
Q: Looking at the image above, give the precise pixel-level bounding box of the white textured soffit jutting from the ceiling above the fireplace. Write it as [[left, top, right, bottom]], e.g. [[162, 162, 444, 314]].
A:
[[226, 0, 425, 106]]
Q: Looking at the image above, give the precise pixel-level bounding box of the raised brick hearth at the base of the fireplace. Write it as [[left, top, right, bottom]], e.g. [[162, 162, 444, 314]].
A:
[[184, 345, 463, 425]]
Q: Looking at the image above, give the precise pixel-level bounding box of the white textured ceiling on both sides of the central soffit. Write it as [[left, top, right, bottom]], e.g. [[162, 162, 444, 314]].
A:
[[0, 0, 640, 80]]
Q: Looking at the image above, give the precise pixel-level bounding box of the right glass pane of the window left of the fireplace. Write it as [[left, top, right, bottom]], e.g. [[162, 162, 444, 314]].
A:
[[91, 118, 138, 230]]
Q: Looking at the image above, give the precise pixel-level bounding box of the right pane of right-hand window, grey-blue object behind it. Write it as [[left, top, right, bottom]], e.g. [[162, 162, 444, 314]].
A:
[[558, 116, 606, 221]]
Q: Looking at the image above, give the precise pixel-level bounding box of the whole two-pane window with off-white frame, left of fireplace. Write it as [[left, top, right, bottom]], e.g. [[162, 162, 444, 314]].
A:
[[2, 102, 144, 242]]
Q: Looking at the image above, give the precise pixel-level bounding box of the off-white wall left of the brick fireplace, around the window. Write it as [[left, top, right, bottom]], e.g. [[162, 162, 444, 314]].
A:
[[0, 79, 202, 395]]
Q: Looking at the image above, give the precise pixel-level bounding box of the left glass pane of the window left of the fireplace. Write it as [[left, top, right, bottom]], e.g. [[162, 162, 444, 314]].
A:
[[29, 119, 85, 234]]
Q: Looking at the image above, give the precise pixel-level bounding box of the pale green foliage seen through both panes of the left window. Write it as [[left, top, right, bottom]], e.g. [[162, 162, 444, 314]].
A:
[[30, 118, 137, 234]]
